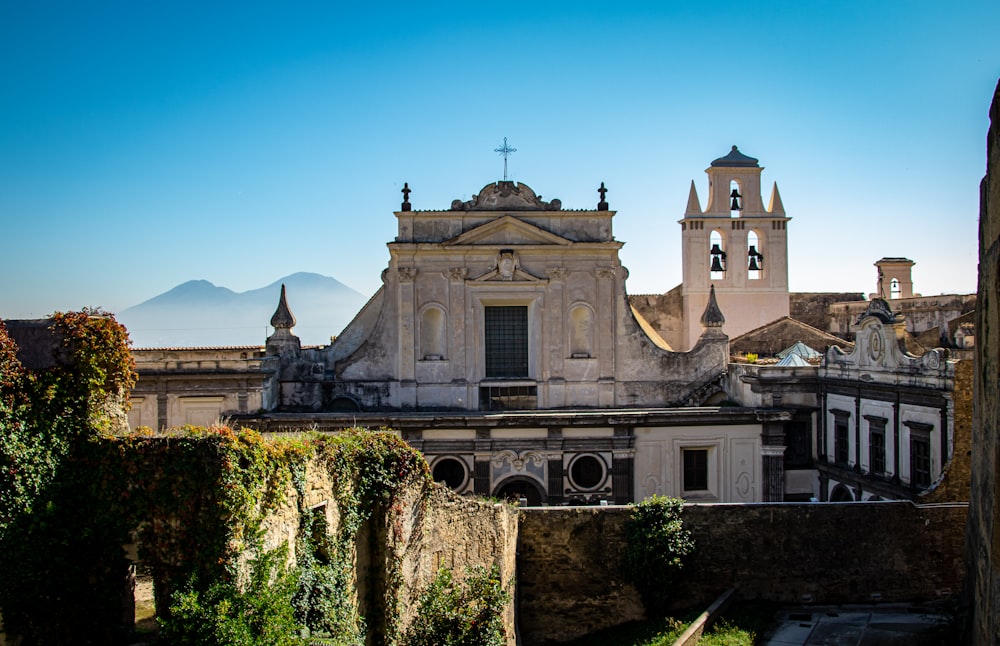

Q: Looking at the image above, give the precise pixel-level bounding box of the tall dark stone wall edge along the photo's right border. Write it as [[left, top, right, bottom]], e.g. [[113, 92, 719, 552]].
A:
[[966, 77, 1000, 644]]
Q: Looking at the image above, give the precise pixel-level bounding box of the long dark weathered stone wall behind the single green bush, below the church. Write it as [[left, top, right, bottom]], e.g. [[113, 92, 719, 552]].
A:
[[518, 502, 967, 646]]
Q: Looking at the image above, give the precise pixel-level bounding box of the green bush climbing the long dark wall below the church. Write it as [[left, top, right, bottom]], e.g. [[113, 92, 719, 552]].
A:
[[622, 496, 694, 614]]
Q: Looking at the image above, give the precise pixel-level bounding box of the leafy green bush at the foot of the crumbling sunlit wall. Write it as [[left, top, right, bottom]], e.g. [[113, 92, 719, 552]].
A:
[[403, 565, 510, 646]]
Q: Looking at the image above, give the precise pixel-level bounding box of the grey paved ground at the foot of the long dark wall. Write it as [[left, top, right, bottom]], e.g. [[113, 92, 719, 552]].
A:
[[762, 604, 949, 646]]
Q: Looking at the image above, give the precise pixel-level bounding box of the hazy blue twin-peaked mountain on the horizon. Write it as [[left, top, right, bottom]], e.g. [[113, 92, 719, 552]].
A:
[[117, 272, 368, 348]]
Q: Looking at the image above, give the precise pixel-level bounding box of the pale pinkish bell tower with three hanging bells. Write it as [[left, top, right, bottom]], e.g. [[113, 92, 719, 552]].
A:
[[680, 146, 791, 350]]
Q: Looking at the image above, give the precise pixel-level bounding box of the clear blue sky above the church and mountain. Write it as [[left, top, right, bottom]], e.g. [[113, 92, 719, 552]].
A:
[[0, 0, 1000, 318]]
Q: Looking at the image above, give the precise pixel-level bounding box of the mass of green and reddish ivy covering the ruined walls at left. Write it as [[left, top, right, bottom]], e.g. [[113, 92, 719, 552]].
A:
[[0, 312, 450, 646]]
